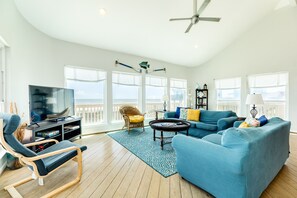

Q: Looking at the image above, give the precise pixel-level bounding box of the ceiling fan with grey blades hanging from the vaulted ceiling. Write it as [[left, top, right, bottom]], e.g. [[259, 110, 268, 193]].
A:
[[169, 0, 221, 33]]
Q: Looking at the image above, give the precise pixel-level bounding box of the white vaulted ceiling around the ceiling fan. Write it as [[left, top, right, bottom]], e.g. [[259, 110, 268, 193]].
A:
[[15, 0, 279, 66]]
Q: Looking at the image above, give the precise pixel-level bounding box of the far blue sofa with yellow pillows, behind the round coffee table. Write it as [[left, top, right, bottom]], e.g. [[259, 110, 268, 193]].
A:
[[164, 110, 237, 138]]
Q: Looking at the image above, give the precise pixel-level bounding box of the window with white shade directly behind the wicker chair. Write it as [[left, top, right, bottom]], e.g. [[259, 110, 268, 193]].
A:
[[112, 72, 141, 121]]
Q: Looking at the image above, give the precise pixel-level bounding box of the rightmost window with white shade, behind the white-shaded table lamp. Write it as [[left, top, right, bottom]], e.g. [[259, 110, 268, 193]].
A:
[[248, 72, 289, 119]]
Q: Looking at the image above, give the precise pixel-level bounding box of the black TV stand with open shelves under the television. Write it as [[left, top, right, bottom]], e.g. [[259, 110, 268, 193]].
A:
[[28, 117, 81, 150]]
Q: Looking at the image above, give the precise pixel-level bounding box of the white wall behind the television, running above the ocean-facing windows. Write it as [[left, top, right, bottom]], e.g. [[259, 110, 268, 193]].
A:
[[0, 0, 188, 133]]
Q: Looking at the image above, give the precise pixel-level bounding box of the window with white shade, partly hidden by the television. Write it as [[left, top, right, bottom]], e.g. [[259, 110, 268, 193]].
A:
[[65, 66, 106, 125]]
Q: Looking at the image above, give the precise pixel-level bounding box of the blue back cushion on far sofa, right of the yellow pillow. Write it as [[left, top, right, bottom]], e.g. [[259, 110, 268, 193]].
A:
[[200, 110, 236, 125]]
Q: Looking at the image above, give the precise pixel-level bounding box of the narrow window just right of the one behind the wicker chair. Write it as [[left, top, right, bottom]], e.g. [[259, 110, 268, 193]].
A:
[[145, 76, 167, 118]]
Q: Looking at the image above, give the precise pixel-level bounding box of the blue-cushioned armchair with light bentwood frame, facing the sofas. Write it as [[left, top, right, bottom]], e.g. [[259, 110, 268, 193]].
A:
[[0, 113, 87, 197]]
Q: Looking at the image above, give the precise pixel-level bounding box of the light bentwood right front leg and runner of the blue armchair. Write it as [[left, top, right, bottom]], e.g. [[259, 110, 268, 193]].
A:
[[41, 155, 82, 198]]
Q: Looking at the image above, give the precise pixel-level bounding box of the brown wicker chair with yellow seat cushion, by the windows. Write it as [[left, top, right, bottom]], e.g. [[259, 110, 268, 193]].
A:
[[120, 105, 145, 132]]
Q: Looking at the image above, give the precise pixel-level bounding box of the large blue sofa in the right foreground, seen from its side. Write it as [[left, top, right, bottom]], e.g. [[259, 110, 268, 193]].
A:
[[173, 118, 291, 198]]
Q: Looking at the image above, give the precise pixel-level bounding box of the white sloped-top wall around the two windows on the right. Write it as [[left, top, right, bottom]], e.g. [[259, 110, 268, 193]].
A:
[[191, 7, 297, 131]]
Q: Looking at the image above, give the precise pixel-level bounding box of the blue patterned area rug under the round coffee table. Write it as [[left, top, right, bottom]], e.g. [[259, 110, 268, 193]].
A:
[[108, 127, 177, 177]]
